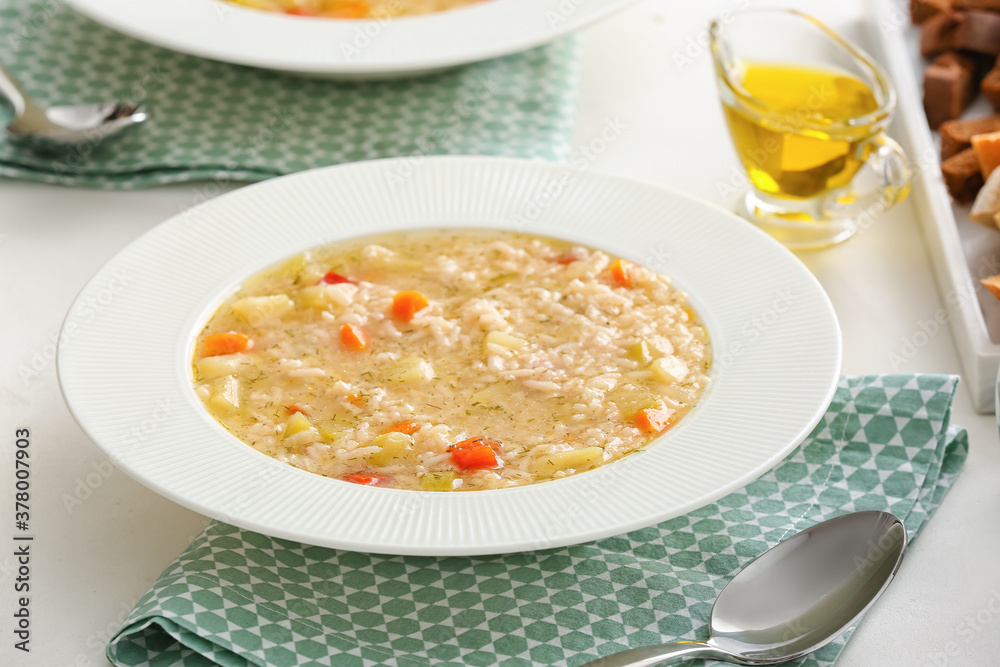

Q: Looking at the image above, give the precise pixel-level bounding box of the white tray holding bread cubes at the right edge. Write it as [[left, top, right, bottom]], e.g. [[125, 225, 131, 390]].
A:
[[877, 0, 1000, 413]]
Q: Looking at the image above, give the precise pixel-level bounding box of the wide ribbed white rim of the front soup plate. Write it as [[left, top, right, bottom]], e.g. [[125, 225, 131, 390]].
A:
[[57, 157, 841, 556]]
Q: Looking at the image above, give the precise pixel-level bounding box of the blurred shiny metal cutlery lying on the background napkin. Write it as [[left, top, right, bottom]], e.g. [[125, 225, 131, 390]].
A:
[[0, 65, 147, 151]]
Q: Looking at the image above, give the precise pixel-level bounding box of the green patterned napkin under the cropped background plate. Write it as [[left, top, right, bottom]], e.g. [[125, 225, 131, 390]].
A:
[[0, 0, 580, 188]]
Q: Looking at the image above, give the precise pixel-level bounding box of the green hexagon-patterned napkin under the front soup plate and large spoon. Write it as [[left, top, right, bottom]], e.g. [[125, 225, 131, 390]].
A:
[[108, 375, 968, 667]]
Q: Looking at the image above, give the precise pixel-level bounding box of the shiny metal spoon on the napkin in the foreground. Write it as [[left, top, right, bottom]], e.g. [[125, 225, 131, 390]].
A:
[[582, 511, 906, 667]]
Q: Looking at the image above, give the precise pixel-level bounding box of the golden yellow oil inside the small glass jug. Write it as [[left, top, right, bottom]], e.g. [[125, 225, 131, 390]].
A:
[[723, 62, 879, 198]]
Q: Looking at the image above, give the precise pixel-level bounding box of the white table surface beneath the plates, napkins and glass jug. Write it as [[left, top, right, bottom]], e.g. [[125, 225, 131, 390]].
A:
[[0, 0, 1000, 667]]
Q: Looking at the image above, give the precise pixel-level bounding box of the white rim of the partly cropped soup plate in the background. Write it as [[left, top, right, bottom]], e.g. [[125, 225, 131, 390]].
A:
[[68, 0, 633, 78]]
